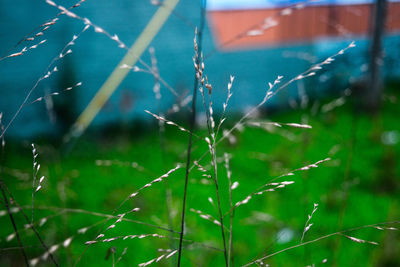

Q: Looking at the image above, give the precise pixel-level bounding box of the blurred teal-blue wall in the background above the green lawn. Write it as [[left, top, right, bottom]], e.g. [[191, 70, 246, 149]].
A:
[[0, 0, 400, 136]]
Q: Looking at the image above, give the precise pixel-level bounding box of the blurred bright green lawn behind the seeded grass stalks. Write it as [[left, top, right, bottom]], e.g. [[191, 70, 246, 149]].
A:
[[0, 87, 400, 266]]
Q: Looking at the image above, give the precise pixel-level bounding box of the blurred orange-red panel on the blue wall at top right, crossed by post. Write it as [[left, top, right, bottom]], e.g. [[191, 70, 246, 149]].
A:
[[208, 2, 400, 50]]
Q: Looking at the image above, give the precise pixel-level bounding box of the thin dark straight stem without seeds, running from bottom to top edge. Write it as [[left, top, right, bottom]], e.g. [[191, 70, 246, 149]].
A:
[[178, 0, 207, 267]]
